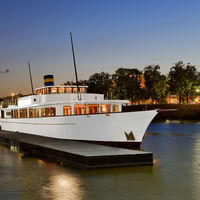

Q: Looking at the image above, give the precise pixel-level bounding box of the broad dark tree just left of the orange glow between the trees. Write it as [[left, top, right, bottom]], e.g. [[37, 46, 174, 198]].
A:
[[112, 68, 142, 103]]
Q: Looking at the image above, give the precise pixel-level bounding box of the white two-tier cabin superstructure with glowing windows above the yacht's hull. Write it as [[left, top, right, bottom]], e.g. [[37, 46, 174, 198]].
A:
[[0, 85, 128, 118]]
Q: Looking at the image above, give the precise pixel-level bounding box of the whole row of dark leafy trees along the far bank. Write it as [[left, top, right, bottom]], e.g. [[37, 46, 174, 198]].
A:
[[65, 61, 200, 103]]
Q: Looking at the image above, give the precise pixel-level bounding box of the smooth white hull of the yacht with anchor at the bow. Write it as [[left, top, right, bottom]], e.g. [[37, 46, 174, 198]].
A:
[[0, 110, 157, 147]]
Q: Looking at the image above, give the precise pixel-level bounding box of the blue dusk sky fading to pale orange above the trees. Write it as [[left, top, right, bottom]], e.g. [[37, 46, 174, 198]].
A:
[[0, 0, 200, 97]]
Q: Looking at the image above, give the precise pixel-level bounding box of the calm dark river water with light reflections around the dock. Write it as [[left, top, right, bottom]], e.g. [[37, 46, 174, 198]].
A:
[[0, 121, 200, 200]]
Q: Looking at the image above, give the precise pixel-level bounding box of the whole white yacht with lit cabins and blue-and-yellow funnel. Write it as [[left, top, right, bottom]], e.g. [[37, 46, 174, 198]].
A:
[[0, 76, 157, 148]]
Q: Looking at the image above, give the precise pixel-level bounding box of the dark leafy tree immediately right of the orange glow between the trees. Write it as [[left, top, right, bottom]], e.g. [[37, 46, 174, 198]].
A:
[[144, 65, 167, 102]]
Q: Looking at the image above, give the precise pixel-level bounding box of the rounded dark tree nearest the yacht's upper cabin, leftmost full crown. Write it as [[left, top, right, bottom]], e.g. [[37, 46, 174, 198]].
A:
[[88, 72, 112, 98]]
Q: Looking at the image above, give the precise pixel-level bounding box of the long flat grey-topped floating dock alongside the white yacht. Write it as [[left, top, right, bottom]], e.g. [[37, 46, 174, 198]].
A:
[[0, 130, 153, 168]]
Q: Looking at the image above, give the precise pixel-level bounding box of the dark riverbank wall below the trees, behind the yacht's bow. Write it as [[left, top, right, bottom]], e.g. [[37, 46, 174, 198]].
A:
[[123, 104, 200, 122]]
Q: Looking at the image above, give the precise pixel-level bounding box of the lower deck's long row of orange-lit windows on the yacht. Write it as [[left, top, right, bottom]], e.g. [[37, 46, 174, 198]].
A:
[[0, 104, 122, 118]]
